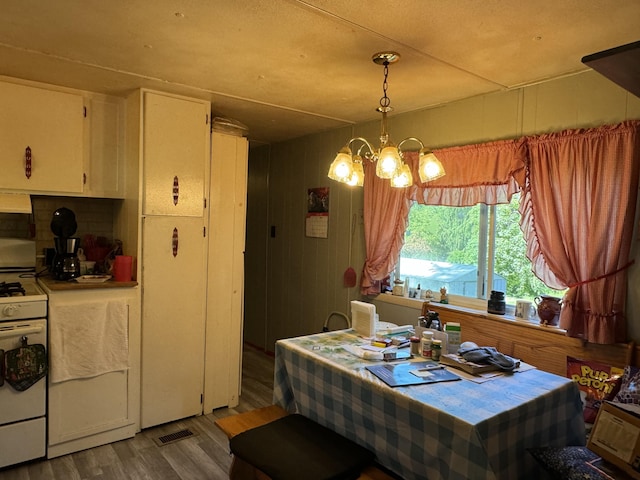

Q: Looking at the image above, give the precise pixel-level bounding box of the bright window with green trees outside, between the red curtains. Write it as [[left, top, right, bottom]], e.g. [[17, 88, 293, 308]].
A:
[[396, 194, 562, 305]]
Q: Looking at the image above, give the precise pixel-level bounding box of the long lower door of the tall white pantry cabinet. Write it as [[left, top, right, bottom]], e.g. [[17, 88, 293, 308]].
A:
[[141, 217, 206, 428]]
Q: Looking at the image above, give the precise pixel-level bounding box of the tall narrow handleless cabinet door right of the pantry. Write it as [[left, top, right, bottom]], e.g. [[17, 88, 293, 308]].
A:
[[204, 132, 247, 412]]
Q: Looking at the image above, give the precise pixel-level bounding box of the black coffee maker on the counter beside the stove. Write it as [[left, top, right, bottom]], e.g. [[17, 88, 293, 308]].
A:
[[51, 207, 80, 281]]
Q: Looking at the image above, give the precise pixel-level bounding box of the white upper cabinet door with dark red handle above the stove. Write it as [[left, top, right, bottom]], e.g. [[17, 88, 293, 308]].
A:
[[0, 82, 84, 193]]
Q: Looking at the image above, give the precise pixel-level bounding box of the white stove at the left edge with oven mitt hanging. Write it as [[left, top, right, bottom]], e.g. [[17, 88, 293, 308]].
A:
[[0, 239, 47, 468]]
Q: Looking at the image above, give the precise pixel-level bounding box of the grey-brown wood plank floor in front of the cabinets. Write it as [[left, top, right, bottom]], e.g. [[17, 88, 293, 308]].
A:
[[0, 345, 273, 480]]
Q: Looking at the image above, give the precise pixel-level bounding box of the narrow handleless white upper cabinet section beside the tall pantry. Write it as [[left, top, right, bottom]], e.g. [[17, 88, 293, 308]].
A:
[[84, 95, 125, 198]]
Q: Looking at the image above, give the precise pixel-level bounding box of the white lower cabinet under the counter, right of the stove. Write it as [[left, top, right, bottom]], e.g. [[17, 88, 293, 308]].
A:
[[45, 286, 140, 458]]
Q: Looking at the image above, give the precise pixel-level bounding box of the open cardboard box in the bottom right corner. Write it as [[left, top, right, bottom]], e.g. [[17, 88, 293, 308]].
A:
[[587, 402, 640, 480]]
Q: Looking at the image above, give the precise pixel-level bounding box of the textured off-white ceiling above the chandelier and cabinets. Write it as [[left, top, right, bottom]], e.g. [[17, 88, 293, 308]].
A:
[[0, 0, 640, 142]]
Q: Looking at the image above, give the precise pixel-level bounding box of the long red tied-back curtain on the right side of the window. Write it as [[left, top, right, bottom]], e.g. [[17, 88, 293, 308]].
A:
[[520, 121, 640, 343]]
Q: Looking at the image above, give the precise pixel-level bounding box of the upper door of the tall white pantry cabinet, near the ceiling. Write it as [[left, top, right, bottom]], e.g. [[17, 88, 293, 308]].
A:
[[142, 92, 210, 217]]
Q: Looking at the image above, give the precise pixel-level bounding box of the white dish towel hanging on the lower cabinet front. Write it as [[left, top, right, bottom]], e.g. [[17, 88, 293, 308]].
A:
[[49, 300, 129, 383]]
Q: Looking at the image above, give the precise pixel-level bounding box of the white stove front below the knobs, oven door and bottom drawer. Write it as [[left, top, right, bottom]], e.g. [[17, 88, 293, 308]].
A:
[[0, 319, 47, 468]]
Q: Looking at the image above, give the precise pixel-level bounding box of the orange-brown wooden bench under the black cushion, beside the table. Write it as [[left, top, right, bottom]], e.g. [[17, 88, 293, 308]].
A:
[[215, 405, 396, 480]]
